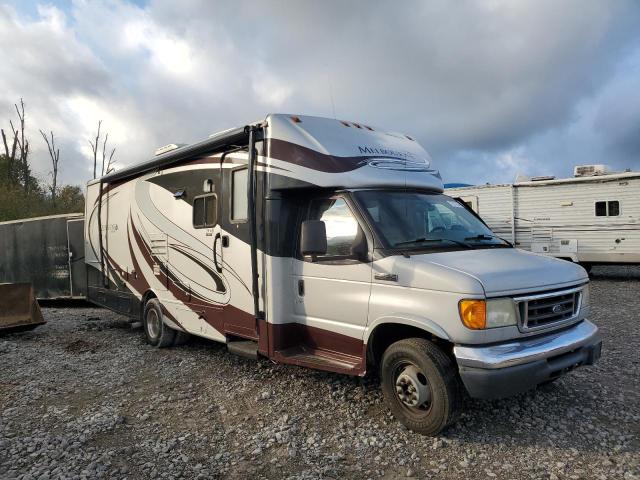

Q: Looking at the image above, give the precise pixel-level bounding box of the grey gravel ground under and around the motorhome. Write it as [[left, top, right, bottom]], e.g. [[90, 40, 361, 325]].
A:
[[0, 267, 640, 479]]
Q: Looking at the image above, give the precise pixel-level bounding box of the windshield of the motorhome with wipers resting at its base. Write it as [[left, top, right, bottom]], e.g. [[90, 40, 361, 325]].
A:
[[355, 190, 508, 249]]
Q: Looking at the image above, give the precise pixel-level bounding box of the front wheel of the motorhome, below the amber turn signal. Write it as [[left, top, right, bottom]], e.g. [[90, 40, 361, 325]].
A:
[[381, 338, 462, 435]]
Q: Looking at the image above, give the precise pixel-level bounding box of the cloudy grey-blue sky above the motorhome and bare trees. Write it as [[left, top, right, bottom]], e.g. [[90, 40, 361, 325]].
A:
[[0, 0, 640, 188]]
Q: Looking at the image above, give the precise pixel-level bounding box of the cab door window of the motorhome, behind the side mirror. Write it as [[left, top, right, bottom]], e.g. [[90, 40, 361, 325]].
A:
[[309, 198, 358, 256]]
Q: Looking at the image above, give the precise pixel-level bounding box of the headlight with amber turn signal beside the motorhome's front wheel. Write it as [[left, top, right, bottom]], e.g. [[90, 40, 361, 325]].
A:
[[459, 298, 518, 330]]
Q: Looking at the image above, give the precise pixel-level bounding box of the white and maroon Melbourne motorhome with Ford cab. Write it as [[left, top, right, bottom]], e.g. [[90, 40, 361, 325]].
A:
[[86, 114, 601, 434]]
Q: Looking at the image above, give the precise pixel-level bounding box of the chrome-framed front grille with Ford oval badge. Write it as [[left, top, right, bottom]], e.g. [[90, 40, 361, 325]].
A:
[[515, 289, 582, 330]]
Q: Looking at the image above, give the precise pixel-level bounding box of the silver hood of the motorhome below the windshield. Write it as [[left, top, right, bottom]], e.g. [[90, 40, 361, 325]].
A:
[[411, 248, 589, 296]]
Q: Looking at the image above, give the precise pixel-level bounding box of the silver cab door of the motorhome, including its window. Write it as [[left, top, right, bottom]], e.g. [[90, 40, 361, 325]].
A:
[[291, 196, 372, 339]]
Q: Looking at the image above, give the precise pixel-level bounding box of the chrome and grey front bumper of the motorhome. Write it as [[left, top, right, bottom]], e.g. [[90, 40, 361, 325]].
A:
[[453, 320, 602, 399]]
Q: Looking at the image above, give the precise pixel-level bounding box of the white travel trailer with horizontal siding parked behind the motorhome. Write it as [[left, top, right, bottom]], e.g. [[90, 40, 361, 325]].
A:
[[446, 171, 640, 270]]
